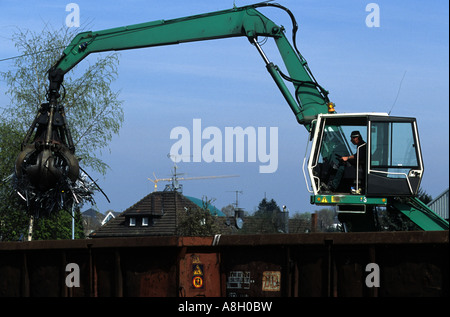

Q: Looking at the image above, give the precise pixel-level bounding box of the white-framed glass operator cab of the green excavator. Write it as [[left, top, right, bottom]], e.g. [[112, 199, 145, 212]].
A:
[[308, 114, 423, 197]]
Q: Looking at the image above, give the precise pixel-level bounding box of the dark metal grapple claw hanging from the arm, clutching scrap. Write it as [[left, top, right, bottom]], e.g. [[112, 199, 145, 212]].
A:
[[14, 102, 87, 213]]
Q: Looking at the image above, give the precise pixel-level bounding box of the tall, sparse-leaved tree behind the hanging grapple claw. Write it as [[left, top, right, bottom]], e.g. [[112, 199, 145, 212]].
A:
[[0, 25, 124, 240]]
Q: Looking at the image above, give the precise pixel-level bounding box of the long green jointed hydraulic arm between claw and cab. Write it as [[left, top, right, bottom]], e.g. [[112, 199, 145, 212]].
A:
[[49, 3, 329, 128]]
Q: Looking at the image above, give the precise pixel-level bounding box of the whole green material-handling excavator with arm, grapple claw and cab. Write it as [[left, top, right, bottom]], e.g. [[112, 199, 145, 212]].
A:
[[15, 2, 449, 231]]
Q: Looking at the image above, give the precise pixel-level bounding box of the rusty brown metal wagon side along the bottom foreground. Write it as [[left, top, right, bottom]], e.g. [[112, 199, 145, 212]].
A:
[[0, 231, 449, 297]]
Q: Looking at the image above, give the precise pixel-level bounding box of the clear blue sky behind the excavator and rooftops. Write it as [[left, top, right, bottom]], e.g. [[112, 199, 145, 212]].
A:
[[0, 0, 449, 214]]
